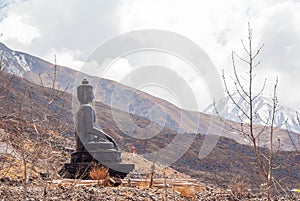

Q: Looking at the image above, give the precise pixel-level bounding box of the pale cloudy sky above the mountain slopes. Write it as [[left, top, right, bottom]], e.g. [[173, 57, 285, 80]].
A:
[[0, 0, 300, 111]]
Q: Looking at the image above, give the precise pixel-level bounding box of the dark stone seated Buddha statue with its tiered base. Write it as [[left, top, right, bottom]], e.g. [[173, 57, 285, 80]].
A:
[[59, 80, 134, 179]]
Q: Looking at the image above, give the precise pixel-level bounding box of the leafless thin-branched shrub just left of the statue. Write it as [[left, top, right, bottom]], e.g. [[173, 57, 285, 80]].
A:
[[24, 55, 69, 199]]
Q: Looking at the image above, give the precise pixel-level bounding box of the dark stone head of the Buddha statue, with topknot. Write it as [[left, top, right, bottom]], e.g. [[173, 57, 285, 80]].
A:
[[77, 79, 94, 104]]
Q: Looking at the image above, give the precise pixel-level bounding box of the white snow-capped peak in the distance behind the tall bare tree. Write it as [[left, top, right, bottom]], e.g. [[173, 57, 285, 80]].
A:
[[202, 93, 300, 133]]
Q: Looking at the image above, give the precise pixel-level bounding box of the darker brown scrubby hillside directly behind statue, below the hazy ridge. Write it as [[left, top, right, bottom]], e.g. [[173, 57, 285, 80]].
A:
[[0, 72, 300, 188]]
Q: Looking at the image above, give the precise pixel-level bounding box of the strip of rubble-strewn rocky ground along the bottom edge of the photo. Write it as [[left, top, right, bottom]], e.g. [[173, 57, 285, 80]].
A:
[[0, 184, 299, 201]]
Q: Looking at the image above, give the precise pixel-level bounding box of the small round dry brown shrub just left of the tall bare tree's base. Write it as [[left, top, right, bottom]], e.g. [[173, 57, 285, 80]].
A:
[[228, 176, 250, 199]]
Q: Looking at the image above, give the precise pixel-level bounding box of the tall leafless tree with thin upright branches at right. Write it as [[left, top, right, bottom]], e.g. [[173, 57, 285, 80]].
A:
[[222, 24, 278, 200]]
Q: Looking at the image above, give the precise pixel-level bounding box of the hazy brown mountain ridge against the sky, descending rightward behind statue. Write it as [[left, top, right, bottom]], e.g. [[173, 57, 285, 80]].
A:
[[0, 44, 300, 150]]
